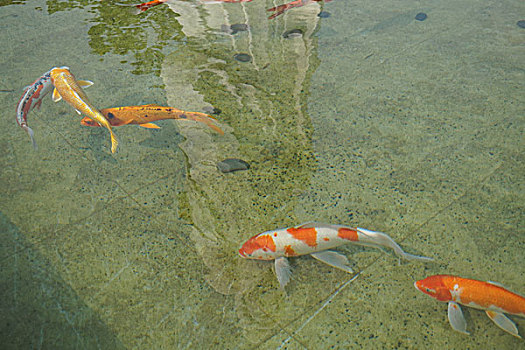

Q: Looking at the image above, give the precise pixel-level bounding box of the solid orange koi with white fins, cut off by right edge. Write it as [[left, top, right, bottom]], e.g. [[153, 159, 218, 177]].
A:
[[414, 275, 525, 338]]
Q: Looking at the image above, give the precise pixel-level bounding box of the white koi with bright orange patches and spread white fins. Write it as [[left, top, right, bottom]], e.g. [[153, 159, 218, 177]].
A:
[[239, 222, 433, 289]]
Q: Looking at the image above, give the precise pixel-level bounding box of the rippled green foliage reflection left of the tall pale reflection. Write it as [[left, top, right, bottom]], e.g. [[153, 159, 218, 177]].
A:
[[47, 0, 183, 75]]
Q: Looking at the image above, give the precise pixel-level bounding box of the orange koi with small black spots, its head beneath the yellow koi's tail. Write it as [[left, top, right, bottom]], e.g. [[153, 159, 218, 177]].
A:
[[80, 104, 224, 135]]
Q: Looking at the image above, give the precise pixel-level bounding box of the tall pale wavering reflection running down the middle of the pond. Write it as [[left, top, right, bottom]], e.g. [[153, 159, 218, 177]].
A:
[[161, 2, 328, 342]]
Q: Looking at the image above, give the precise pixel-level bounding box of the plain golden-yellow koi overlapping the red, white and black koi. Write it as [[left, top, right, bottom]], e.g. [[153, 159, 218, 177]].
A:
[[51, 67, 118, 153]]
